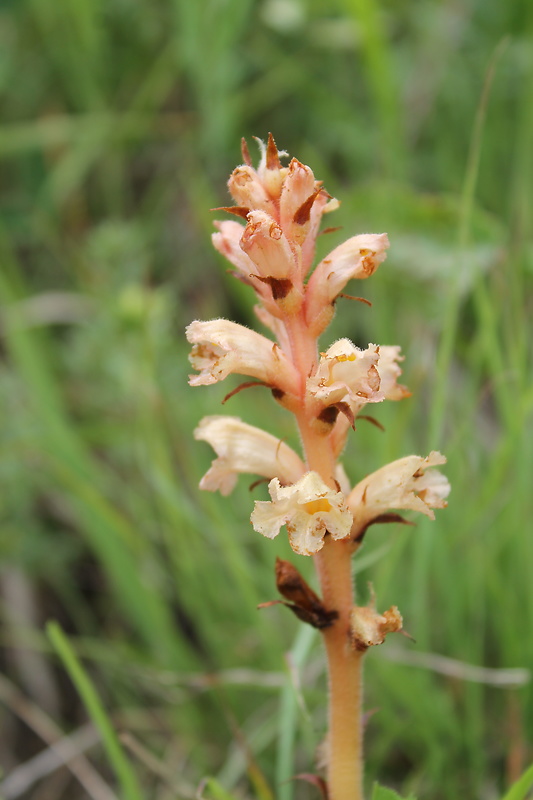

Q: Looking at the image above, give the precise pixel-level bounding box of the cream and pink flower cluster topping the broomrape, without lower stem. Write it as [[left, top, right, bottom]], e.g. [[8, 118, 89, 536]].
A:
[[187, 137, 449, 555]]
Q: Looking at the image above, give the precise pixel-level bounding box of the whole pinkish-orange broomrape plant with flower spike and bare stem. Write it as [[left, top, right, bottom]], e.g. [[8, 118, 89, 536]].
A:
[[187, 135, 450, 800]]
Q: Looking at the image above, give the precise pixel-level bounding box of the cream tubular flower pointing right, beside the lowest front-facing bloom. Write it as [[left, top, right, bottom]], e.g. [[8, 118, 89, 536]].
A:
[[347, 451, 450, 533]]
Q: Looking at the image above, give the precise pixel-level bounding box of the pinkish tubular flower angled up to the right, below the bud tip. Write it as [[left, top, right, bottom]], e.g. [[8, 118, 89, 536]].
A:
[[306, 233, 389, 324]]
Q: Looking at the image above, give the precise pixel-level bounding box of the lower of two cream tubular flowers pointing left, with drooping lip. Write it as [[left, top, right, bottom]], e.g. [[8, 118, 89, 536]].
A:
[[194, 416, 305, 495]]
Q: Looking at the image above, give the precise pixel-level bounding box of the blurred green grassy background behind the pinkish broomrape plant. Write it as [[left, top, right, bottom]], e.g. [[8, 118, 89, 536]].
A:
[[0, 0, 533, 800]]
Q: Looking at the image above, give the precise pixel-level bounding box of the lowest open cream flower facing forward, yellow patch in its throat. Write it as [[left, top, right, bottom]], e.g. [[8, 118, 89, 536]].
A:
[[251, 472, 352, 556]]
